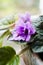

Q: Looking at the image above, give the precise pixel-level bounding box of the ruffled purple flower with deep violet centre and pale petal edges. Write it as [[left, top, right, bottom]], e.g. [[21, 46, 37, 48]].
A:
[[11, 14, 35, 42]]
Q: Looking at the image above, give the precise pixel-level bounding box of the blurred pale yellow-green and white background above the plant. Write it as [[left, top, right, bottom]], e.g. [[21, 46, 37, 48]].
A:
[[0, 0, 43, 18]]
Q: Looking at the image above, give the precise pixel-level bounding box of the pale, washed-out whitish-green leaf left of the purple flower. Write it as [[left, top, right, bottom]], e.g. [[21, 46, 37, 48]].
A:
[[0, 16, 15, 30]]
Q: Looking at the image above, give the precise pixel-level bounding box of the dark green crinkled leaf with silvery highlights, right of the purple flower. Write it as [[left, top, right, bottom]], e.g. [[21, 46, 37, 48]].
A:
[[31, 22, 43, 53]]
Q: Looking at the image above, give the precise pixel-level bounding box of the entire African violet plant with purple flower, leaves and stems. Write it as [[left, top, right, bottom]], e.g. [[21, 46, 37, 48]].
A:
[[0, 13, 43, 65]]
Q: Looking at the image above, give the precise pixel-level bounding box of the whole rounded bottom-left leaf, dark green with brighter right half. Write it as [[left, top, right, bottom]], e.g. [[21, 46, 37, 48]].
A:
[[0, 46, 19, 65]]
